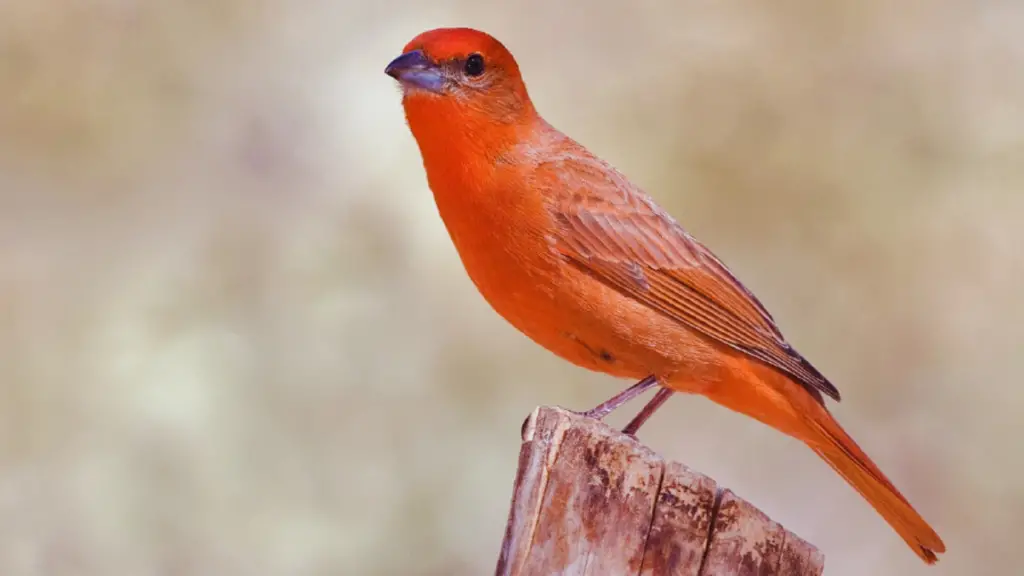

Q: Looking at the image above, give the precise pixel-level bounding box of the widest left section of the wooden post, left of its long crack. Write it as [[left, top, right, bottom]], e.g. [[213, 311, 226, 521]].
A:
[[498, 409, 663, 576]]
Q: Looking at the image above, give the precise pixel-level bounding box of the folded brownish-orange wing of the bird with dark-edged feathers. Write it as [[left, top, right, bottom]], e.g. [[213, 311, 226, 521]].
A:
[[536, 155, 840, 402]]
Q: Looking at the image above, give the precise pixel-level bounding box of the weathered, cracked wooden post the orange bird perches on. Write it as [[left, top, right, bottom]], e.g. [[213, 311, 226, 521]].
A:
[[495, 407, 824, 576]]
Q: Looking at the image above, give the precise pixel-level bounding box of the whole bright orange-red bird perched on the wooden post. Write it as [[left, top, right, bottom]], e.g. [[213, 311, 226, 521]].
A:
[[387, 29, 945, 564]]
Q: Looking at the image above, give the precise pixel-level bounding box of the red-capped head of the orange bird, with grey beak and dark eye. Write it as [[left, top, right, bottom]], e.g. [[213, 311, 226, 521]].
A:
[[385, 28, 535, 132]]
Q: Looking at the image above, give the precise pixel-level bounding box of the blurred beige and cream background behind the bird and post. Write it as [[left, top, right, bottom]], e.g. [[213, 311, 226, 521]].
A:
[[0, 0, 1024, 576]]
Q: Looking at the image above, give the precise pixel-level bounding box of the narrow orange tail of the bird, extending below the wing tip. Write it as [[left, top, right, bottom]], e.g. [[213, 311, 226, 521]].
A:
[[805, 407, 946, 564]]
